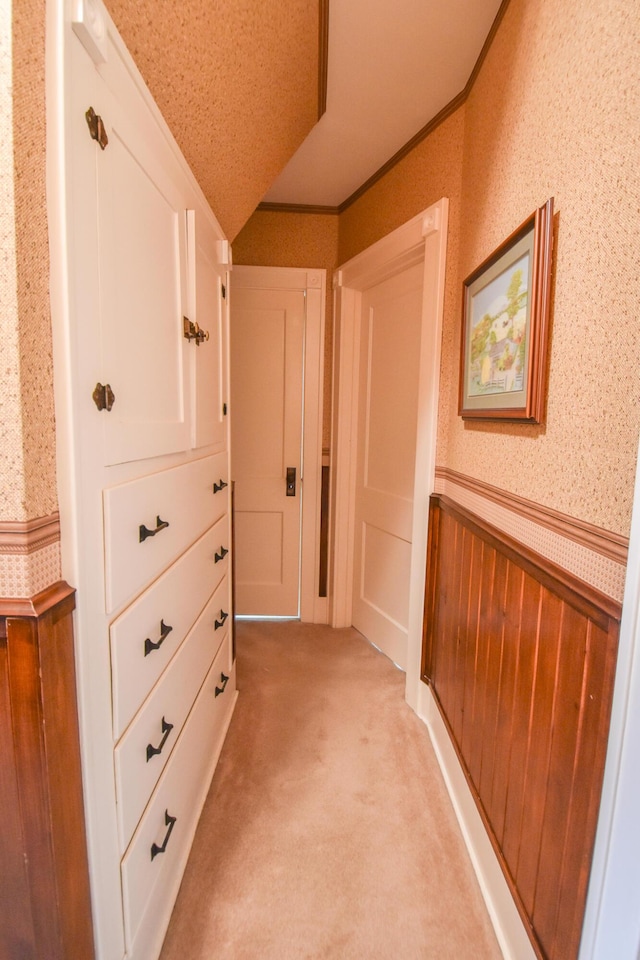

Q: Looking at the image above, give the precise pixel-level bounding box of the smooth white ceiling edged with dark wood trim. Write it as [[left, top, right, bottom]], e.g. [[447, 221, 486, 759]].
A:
[[264, 0, 501, 206]]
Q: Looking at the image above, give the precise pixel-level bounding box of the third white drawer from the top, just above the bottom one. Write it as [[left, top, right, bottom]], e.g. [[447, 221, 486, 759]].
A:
[[114, 577, 229, 850]]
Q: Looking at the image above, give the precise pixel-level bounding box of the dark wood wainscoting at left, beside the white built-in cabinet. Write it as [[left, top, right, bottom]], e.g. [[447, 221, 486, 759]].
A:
[[0, 581, 94, 960]]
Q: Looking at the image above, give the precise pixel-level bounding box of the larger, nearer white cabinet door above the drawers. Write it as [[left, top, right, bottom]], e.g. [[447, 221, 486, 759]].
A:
[[91, 70, 195, 464]]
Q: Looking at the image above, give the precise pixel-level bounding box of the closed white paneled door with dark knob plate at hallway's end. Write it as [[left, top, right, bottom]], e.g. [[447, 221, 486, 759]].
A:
[[231, 285, 305, 617]]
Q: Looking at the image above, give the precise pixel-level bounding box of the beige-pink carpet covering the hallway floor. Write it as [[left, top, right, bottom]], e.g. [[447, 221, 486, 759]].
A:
[[161, 622, 501, 960]]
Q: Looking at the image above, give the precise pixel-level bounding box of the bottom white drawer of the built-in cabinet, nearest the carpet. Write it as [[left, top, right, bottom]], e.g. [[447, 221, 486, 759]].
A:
[[121, 633, 235, 955]]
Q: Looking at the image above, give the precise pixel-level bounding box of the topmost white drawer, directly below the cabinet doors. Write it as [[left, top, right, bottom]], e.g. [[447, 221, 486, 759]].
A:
[[104, 453, 229, 613]]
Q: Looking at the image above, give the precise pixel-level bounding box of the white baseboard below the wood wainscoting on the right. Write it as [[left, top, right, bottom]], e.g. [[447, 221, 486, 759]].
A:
[[417, 683, 536, 960]]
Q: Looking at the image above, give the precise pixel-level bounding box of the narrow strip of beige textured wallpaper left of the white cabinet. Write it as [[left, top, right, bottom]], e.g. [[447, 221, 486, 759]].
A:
[[0, 0, 57, 520]]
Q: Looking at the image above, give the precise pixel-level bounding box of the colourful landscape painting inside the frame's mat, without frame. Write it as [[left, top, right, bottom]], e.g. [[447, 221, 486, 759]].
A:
[[468, 255, 529, 397]]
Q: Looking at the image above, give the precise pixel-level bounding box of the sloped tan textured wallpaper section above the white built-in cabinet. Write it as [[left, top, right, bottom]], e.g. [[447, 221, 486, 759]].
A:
[[106, 0, 318, 240]]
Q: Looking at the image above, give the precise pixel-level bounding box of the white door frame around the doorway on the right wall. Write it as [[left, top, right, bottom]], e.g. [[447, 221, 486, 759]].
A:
[[329, 197, 449, 710]]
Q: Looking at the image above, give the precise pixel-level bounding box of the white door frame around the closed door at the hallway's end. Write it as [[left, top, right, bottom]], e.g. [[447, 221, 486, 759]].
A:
[[229, 265, 327, 623]]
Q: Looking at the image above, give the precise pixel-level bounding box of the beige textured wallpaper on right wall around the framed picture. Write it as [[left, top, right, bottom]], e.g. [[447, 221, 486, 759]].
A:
[[340, 0, 640, 534]]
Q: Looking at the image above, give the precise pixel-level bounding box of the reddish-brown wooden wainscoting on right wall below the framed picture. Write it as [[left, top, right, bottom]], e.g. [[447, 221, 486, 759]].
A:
[[422, 494, 621, 960]]
